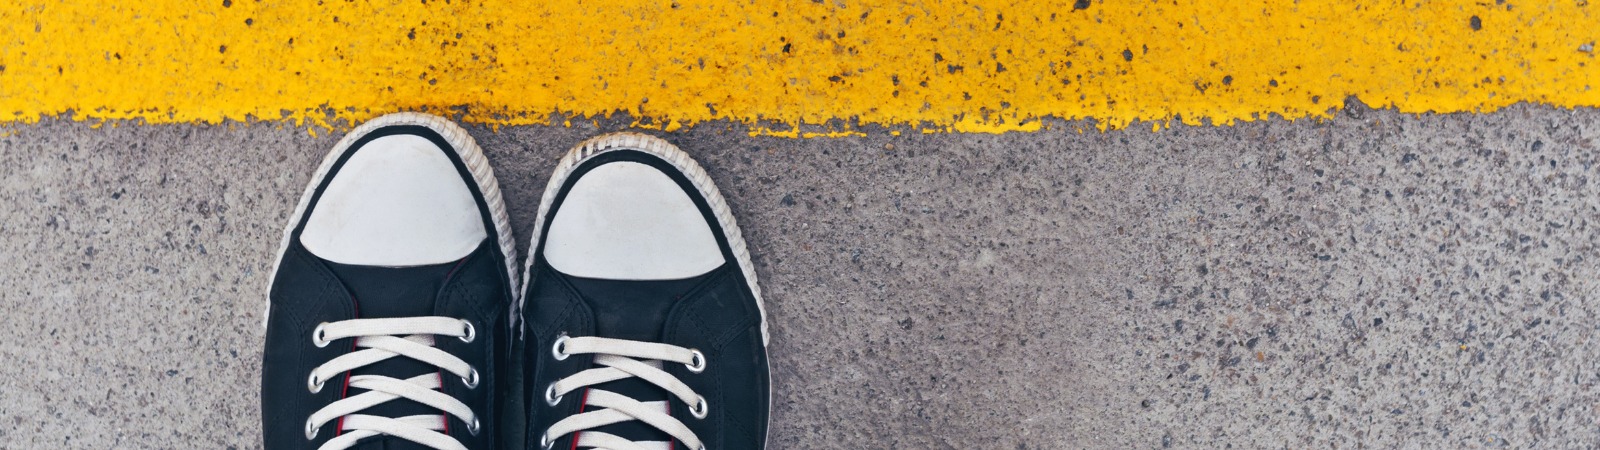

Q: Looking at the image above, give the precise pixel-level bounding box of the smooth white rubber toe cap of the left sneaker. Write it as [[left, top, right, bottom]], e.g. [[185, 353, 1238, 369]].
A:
[[299, 135, 488, 267]]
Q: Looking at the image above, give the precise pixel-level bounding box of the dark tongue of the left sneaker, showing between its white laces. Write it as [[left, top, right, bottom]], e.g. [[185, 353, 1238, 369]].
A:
[[328, 261, 459, 441]]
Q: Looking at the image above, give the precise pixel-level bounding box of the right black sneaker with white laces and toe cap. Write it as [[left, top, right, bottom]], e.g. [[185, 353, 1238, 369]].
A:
[[522, 133, 771, 450]]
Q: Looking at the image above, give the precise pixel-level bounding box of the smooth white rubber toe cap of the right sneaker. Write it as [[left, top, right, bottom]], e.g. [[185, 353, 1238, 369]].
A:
[[544, 162, 723, 280]]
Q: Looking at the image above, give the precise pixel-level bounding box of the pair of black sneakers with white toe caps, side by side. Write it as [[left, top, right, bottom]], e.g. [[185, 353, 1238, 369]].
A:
[[261, 114, 770, 450]]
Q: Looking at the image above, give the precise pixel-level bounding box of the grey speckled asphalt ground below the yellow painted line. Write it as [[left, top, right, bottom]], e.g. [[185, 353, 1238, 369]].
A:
[[0, 106, 1600, 450]]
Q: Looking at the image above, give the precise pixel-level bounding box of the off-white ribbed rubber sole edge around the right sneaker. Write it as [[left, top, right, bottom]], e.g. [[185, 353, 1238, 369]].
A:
[[515, 131, 773, 447]]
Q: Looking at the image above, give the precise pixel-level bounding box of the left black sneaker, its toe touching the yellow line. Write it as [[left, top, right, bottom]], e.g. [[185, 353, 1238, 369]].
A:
[[261, 114, 522, 450]]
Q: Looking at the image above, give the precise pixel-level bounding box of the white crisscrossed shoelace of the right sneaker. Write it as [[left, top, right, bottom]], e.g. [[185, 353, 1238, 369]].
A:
[[539, 336, 709, 450]]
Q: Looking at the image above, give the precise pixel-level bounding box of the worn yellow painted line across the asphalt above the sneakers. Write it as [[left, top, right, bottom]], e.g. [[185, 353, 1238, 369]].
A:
[[0, 0, 1600, 136]]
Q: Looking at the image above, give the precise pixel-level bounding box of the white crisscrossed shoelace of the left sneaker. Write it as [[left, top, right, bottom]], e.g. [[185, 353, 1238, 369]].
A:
[[306, 317, 478, 450]]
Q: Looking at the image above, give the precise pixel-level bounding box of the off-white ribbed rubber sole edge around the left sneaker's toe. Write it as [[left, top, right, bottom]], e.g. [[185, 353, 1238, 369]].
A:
[[261, 112, 522, 328]]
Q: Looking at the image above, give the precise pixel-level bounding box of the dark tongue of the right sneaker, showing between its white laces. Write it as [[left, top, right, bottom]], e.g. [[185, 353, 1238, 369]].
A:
[[568, 271, 715, 442]]
